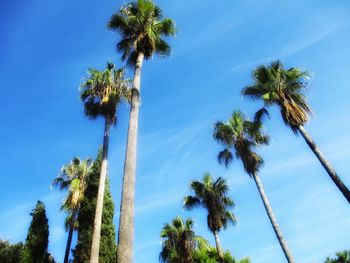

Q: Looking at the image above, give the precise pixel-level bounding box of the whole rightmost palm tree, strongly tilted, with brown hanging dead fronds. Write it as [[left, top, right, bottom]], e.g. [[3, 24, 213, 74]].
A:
[[242, 61, 350, 203]]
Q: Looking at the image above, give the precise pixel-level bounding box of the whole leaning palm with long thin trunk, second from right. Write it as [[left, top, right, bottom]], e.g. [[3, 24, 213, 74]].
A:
[[213, 111, 294, 263]]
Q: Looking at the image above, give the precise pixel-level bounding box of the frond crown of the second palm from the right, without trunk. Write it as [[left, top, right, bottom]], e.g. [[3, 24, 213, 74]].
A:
[[213, 111, 269, 176]]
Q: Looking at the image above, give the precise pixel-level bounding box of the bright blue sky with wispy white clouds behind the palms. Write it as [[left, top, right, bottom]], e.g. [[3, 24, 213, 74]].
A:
[[0, 0, 350, 263]]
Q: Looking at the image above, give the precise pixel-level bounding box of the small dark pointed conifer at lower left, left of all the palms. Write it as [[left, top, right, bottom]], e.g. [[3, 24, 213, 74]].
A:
[[20, 201, 54, 263]]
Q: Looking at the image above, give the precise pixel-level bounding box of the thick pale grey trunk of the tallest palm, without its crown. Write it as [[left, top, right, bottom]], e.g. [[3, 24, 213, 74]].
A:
[[117, 53, 144, 263]]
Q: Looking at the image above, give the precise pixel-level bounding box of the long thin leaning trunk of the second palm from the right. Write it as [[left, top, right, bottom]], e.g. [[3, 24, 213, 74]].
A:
[[253, 174, 295, 263]]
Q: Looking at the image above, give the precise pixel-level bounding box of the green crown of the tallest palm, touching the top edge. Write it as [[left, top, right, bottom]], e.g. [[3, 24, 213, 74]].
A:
[[108, 0, 176, 64]]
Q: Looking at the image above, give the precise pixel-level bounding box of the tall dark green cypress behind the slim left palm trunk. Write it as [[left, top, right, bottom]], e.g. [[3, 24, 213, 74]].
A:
[[73, 151, 117, 263]]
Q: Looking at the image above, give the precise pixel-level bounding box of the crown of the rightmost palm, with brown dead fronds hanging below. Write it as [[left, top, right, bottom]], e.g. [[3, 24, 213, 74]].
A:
[[242, 61, 311, 132]]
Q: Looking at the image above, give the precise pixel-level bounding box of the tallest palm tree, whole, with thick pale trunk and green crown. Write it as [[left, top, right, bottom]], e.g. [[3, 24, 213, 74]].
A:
[[108, 0, 175, 263]]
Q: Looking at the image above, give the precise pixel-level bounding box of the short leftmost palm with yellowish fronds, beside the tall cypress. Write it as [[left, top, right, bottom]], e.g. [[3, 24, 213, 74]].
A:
[[53, 157, 92, 263]]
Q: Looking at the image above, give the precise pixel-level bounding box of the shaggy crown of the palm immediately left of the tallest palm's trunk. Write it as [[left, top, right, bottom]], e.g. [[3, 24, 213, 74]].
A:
[[80, 62, 130, 123]]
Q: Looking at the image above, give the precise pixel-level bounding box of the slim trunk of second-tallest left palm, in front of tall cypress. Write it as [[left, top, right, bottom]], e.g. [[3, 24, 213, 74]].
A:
[[90, 116, 111, 263]]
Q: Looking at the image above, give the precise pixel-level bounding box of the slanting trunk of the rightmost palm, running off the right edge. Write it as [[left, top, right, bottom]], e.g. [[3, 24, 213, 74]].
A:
[[298, 125, 350, 203]]
